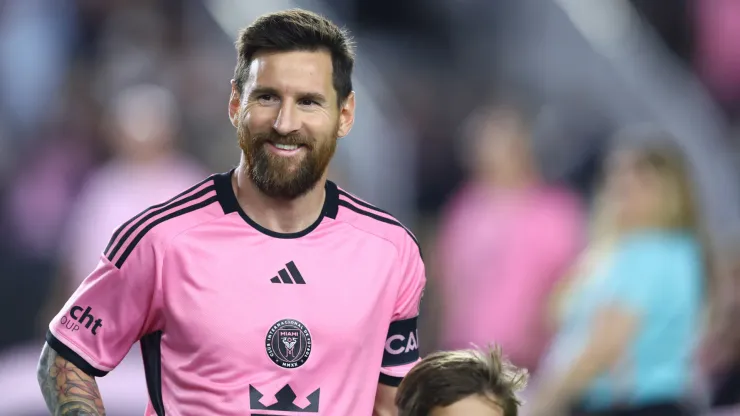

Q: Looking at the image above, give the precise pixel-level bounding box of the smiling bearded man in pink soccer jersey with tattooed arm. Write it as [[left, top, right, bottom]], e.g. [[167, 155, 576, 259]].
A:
[[38, 10, 426, 416]]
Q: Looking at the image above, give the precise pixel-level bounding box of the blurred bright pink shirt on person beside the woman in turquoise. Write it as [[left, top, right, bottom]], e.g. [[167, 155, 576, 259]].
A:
[[437, 185, 583, 369]]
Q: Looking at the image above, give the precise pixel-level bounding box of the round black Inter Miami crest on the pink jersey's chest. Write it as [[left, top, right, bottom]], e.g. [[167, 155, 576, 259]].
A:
[[265, 319, 311, 368]]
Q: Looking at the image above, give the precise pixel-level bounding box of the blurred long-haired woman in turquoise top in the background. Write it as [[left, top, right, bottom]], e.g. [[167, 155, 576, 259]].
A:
[[530, 130, 711, 416]]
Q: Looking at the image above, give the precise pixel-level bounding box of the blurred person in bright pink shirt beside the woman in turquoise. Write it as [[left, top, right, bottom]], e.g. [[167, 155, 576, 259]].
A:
[[436, 104, 584, 372]]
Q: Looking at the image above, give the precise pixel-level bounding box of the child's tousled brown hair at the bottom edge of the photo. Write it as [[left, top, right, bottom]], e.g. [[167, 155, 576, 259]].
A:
[[396, 347, 527, 416]]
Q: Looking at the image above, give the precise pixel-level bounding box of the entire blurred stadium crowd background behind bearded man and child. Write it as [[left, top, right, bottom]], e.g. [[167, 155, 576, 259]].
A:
[[0, 0, 740, 416]]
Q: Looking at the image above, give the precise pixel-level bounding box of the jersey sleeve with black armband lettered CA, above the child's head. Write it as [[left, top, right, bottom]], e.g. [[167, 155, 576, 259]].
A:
[[380, 236, 426, 386]]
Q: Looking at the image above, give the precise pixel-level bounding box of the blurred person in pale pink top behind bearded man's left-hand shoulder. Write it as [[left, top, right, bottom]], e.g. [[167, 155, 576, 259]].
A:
[[40, 84, 206, 415]]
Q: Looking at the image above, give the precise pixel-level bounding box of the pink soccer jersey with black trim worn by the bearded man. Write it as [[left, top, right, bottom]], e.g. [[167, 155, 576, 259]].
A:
[[46, 171, 426, 416]]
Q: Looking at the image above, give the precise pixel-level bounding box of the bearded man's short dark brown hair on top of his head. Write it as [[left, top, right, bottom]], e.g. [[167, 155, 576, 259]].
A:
[[234, 9, 355, 104]]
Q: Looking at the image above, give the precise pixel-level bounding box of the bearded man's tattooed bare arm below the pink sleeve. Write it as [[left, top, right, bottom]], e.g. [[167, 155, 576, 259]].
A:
[[36, 345, 105, 416]]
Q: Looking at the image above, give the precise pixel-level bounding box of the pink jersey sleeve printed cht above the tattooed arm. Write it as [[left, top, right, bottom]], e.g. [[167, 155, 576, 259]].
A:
[[46, 232, 161, 377]]
